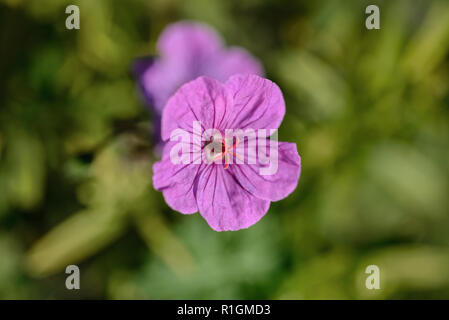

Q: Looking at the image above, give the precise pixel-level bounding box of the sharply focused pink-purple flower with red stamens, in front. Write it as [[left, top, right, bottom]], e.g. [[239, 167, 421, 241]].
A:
[[153, 75, 301, 231]]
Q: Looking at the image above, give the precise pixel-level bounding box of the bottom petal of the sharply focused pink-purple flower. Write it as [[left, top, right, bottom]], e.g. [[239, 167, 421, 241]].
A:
[[196, 164, 270, 231]]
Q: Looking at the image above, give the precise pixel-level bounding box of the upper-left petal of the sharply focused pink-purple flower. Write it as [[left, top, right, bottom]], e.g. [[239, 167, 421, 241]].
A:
[[162, 77, 229, 141]]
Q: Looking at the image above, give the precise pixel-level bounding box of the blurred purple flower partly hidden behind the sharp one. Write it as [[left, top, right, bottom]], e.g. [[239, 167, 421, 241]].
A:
[[134, 21, 263, 114]]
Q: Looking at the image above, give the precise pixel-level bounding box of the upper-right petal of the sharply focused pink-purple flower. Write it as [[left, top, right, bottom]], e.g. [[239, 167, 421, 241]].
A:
[[220, 74, 285, 130]]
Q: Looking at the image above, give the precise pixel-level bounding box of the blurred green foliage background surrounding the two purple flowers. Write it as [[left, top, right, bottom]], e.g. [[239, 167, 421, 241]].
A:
[[0, 0, 449, 299]]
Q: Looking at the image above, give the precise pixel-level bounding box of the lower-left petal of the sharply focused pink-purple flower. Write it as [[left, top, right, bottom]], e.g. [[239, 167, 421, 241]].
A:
[[153, 141, 204, 214]]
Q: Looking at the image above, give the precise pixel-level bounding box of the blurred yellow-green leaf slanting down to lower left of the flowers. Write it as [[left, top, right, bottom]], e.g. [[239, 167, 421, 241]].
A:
[[26, 137, 150, 276]]
